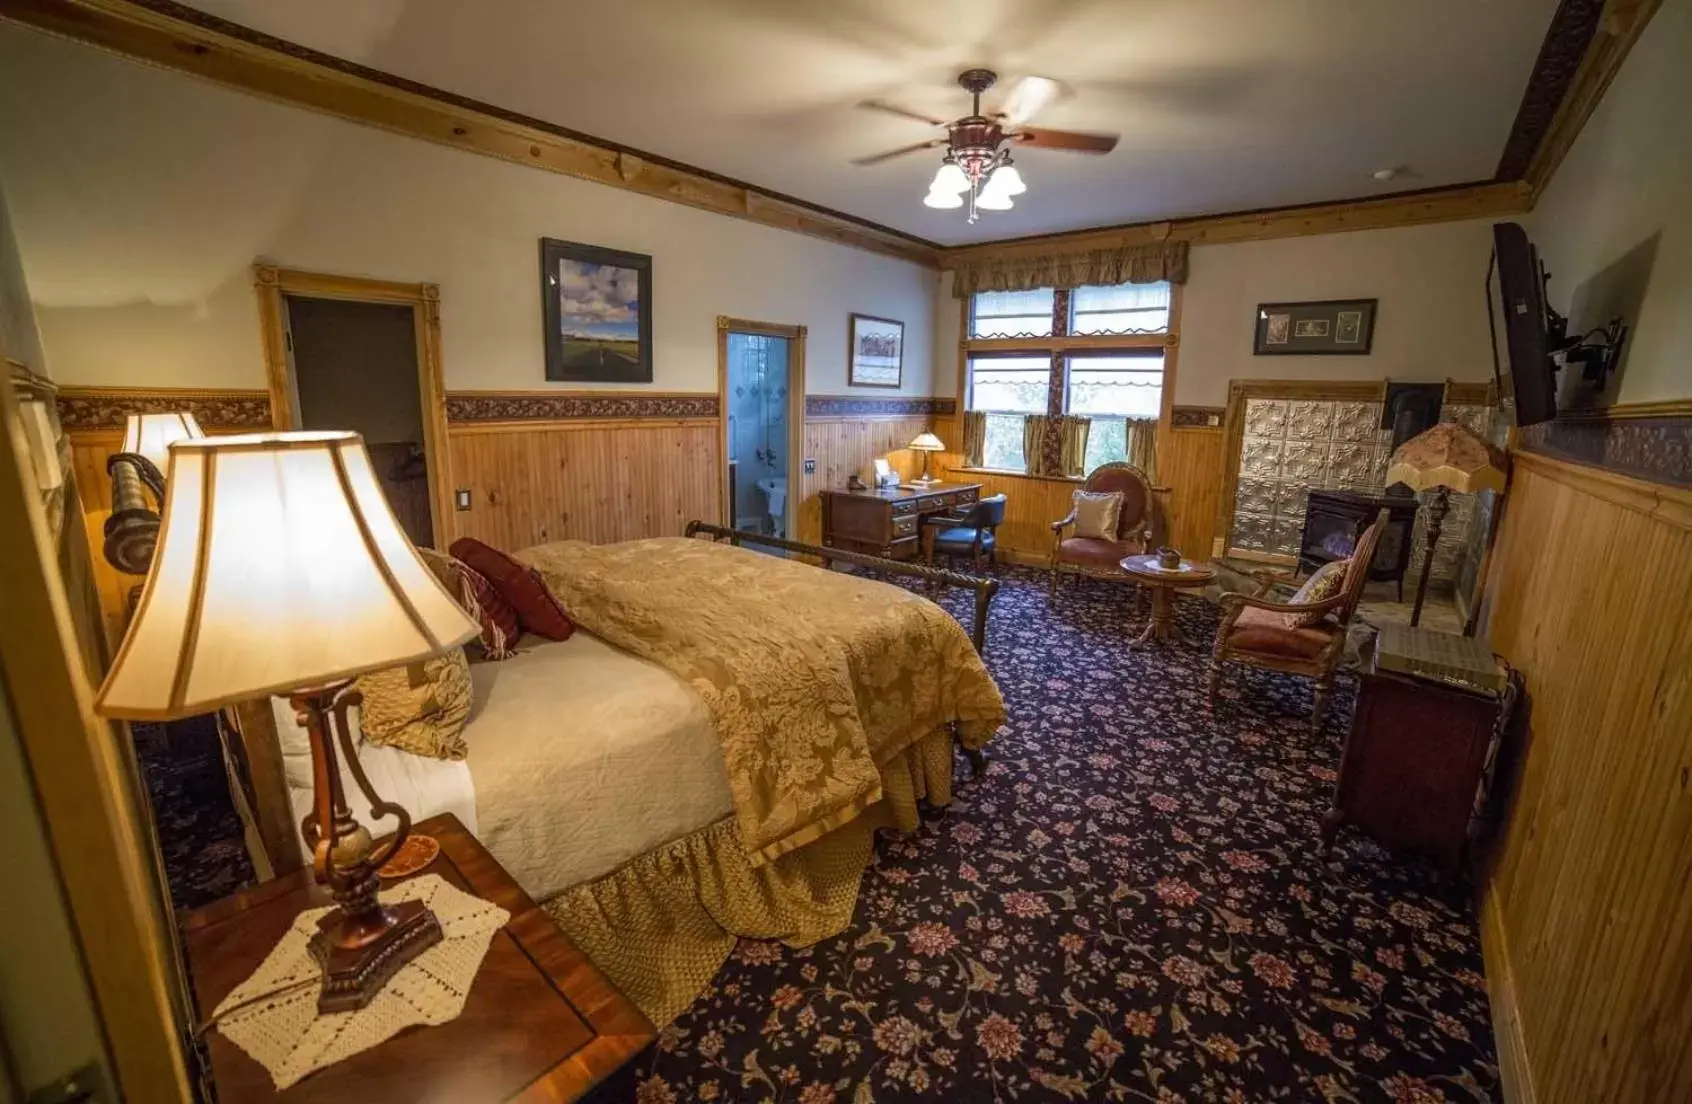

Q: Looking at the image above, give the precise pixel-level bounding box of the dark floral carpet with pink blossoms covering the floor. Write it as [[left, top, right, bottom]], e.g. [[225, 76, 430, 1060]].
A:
[[594, 569, 1497, 1104]]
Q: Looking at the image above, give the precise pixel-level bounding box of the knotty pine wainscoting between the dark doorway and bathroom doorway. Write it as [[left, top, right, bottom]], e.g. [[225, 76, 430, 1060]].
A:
[[447, 418, 721, 550]]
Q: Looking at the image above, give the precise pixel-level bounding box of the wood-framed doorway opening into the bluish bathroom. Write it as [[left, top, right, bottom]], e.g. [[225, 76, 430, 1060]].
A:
[[717, 318, 805, 540]]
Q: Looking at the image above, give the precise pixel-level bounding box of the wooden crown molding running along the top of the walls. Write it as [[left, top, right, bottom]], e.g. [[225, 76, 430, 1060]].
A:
[[0, 0, 1637, 269]]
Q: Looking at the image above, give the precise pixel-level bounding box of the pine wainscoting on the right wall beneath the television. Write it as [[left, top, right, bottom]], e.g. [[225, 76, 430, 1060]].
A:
[[1484, 452, 1692, 1104]]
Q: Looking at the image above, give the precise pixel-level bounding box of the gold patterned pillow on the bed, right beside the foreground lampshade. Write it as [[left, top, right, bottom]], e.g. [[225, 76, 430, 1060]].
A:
[[354, 649, 470, 759]]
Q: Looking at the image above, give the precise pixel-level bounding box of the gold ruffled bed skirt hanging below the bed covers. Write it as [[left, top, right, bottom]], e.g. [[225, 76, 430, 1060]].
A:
[[545, 730, 953, 1026]]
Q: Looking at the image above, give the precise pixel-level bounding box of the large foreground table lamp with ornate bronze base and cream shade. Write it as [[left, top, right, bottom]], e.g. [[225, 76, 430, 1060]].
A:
[[95, 432, 477, 1013]]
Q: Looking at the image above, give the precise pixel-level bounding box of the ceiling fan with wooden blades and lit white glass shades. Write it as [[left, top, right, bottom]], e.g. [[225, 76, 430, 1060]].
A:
[[853, 69, 1117, 222]]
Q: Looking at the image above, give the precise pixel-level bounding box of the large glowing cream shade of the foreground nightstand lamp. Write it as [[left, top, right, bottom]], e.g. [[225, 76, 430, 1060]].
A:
[[95, 432, 477, 720]]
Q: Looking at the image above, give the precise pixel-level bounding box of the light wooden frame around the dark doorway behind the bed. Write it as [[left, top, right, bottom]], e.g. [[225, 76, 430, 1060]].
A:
[[252, 264, 455, 550]]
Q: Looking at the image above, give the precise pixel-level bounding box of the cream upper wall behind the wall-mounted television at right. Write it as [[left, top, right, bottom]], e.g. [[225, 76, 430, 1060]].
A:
[[1528, 0, 1692, 403]]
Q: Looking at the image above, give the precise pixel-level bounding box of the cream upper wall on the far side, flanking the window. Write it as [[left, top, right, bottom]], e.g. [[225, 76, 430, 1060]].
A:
[[934, 220, 1492, 406]]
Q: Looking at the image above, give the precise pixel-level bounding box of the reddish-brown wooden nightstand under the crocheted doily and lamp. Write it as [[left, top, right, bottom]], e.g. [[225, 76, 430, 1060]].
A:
[[183, 814, 655, 1104]]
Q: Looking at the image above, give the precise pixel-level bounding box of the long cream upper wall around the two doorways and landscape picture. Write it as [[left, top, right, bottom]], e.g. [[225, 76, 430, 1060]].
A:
[[0, 24, 949, 398]]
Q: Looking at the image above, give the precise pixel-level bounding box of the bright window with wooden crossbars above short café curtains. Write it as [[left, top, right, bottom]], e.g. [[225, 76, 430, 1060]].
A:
[[964, 283, 1174, 471]]
